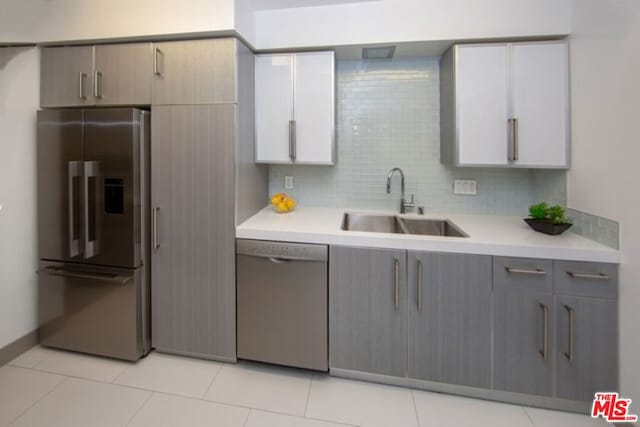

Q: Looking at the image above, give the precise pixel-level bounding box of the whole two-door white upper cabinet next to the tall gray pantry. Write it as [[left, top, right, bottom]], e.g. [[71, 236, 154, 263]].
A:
[[255, 52, 335, 165]]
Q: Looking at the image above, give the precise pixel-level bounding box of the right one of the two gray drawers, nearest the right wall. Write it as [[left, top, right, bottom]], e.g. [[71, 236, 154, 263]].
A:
[[554, 261, 618, 299]]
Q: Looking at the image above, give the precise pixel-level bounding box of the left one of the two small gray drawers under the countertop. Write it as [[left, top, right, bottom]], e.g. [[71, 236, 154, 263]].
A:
[[493, 257, 553, 294]]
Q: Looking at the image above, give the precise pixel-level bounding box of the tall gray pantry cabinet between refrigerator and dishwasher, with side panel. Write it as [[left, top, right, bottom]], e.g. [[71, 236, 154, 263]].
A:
[[151, 39, 267, 361]]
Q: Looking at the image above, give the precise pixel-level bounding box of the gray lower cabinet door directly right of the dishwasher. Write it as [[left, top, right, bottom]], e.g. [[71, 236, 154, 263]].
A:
[[329, 246, 406, 377]]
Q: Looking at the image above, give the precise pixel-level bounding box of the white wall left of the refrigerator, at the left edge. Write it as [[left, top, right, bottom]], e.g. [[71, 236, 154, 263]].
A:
[[0, 48, 40, 348]]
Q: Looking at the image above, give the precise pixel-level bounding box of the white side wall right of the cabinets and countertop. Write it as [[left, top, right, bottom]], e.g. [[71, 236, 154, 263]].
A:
[[568, 0, 640, 413]]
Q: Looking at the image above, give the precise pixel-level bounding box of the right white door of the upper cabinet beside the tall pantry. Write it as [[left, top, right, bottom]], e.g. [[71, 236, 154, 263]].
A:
[[294, 52, 335, 165]]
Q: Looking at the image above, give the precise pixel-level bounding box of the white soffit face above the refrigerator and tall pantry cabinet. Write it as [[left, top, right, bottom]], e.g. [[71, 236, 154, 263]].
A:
[[0, 0, 235, 42]]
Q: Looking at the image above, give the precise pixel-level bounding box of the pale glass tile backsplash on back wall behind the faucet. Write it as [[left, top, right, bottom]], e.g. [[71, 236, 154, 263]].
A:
[[269, 58, 566, 216]]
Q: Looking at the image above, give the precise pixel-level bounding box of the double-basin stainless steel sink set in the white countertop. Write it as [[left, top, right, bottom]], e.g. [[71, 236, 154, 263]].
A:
[[341, 213, 469, 237]]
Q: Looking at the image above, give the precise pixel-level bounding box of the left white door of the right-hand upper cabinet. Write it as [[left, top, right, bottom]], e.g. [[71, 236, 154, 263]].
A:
[[455, 44, 509, 166]]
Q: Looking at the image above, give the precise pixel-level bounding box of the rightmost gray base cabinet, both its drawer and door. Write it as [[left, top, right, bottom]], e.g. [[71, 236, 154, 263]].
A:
[[555, 261, 618, 401]]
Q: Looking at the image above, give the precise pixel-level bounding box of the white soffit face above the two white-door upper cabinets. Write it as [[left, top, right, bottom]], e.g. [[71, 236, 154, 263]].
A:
[[256, 0, 571, 49]]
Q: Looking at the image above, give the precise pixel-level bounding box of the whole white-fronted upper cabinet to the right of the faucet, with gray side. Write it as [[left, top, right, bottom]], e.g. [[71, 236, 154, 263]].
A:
[[440, 41, 569, 168]]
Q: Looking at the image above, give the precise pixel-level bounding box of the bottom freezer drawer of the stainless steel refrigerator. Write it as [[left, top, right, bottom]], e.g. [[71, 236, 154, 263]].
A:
[[38, 262, 150, 360]]
